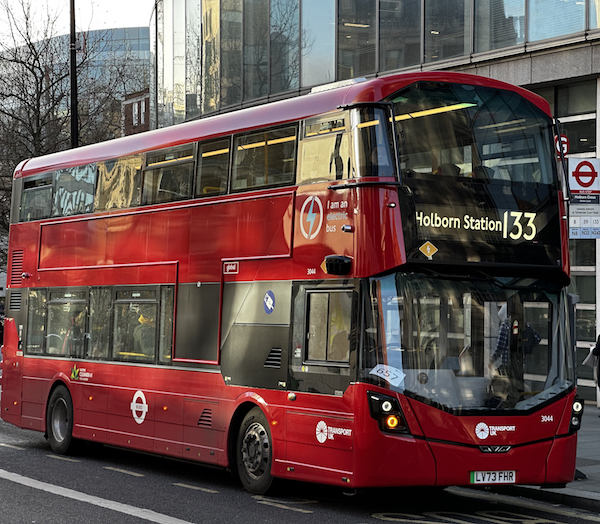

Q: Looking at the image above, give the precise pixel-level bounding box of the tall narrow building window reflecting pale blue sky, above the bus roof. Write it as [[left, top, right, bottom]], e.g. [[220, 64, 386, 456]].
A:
[[301, 0, 336, 87]]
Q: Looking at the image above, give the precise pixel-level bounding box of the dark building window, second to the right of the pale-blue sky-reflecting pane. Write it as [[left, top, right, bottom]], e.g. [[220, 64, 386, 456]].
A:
[[379, 0, 421, 71]]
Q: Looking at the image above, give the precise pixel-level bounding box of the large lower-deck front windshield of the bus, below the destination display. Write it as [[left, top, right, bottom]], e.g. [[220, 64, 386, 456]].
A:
[[362, 273, 574, 412]]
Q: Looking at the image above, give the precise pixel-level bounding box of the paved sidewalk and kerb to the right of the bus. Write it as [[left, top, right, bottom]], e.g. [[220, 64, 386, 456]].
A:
[[494, 402, 600, 511]]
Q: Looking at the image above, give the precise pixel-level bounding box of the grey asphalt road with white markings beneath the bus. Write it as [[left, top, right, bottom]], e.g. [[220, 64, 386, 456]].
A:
[[0, 421, 600, 524]]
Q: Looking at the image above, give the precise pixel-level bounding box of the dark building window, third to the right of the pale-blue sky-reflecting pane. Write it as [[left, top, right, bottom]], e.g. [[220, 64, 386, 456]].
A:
[[425, 0, 471, 62]]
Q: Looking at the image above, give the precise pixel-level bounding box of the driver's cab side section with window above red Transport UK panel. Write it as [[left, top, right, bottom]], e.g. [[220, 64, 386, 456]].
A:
[[286, 281, 358, 484]]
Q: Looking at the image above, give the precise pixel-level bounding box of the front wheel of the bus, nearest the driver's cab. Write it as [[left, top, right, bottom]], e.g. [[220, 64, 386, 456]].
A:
[[236, 408, 273, 495]]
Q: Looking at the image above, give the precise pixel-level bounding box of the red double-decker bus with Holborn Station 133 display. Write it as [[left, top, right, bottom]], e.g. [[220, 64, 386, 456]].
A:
[[1, 72, 582, 493]]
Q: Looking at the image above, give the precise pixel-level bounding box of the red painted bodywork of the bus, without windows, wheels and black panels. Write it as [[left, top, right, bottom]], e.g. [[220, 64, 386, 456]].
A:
[[1, 72, 576, 487]]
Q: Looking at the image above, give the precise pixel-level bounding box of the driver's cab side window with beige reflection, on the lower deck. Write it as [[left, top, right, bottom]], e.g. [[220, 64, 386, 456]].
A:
[[306, 291, 352, 363]]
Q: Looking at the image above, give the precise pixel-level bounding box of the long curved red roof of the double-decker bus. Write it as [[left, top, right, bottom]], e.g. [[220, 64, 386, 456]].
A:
[[14, 71, 551, 178]]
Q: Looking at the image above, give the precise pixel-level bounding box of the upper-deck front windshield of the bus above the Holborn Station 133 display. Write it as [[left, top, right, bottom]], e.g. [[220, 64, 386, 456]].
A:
[[392, 82, 556, 184]]
